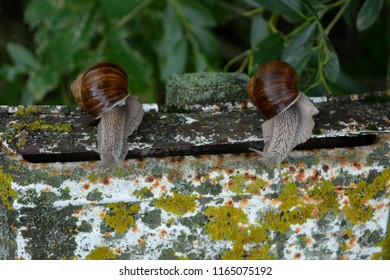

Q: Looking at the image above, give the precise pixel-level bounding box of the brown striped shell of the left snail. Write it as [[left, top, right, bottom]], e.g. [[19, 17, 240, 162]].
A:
[[71, 62, 129, 118]]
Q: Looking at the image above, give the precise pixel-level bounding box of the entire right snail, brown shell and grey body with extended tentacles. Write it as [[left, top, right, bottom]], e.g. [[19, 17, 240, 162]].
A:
[[247, 61, 319, 182]]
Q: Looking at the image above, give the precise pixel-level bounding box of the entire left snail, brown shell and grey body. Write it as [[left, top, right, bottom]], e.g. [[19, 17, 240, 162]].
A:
[[71, 62, 144, 167]]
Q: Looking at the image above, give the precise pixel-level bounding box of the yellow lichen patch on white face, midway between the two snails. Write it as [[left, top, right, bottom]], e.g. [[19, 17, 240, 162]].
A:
[[154, 193, 196, 216]]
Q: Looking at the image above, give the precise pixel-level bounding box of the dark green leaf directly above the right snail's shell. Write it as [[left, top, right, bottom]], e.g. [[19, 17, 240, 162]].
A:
[[253, 33, 283, 69]]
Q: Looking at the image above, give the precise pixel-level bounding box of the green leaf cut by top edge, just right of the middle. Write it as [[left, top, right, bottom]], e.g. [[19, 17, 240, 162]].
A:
[[178, 0, 216, 27]]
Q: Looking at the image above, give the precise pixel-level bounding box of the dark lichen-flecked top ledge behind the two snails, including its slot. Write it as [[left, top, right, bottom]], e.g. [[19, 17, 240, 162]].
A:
[[0, 94, 390, 162]]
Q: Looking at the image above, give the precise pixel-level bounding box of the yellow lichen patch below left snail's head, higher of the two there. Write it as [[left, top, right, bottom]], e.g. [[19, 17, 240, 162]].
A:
[[104, 203, 140, 234]]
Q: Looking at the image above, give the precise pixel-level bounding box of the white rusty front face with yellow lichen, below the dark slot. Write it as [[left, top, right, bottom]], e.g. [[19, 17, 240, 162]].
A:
[[1, 135, 390, 259]]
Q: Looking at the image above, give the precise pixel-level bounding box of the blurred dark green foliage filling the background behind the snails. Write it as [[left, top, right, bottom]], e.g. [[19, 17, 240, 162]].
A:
[[0, 0, 390, 104]]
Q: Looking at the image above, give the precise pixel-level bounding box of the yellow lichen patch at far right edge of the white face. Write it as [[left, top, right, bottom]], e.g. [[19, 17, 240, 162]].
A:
[[343, 167, 390, 224]]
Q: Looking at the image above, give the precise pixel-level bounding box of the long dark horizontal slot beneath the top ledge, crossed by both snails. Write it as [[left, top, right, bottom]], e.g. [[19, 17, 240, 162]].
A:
[[21, 135, 377, 163]]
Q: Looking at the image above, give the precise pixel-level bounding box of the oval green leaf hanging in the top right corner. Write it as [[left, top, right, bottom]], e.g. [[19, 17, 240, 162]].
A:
[[356, 0, 383, 31]]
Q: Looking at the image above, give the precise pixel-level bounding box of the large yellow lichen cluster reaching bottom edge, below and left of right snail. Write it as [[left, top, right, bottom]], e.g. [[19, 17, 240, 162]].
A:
[[204, 205, 274, 259]]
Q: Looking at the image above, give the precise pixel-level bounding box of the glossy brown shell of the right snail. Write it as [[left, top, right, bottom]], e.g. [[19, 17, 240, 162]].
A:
[[247, 61, 300, 119]]
